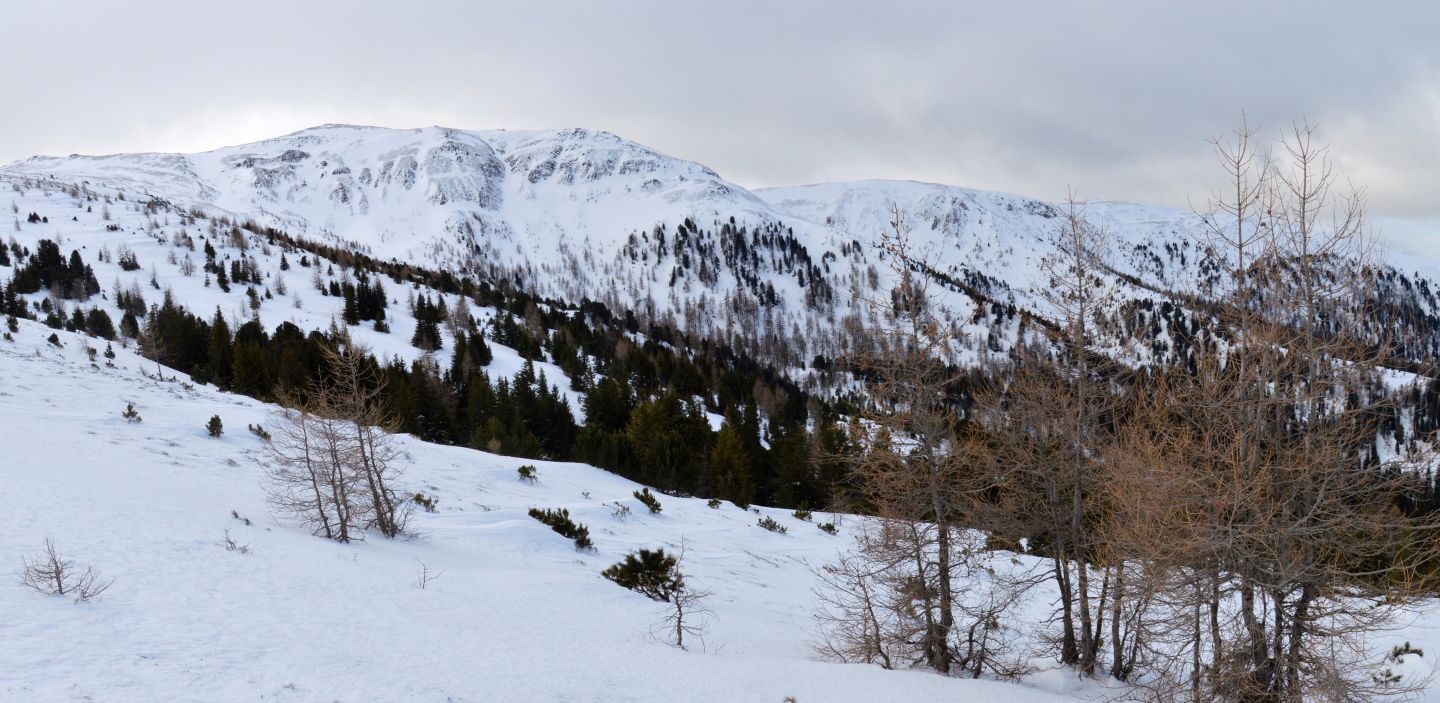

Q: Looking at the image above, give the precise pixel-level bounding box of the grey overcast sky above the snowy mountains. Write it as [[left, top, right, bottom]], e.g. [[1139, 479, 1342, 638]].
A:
[[8, 0, 1440, 258]]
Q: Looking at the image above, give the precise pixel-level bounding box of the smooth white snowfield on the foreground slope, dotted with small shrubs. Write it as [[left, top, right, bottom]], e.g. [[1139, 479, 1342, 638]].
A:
[[0, 315, 1100, 703]]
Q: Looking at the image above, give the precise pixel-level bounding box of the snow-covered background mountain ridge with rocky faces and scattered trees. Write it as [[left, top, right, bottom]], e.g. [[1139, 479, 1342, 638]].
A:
[[8, 125, 1440, 380]]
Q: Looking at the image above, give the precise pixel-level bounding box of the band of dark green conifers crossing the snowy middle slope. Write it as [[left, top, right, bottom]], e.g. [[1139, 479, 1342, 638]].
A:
[[0, 216, 844, 507]]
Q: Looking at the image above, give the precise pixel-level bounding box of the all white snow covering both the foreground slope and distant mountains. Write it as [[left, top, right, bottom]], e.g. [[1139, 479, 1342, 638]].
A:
[[8, 125, 1440, 703]]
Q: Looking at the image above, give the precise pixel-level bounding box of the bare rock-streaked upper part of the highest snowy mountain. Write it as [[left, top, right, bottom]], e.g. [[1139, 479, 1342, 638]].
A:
[[3, 125, 765, 256]]
